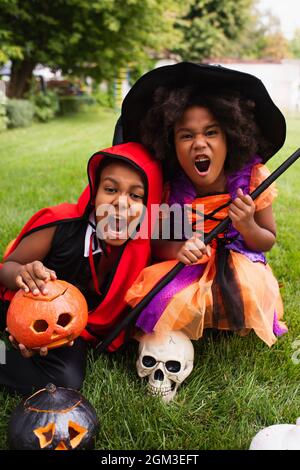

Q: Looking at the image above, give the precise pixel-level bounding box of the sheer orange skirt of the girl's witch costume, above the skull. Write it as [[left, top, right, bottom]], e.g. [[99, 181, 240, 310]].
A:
[[125, 248, 287, 346]]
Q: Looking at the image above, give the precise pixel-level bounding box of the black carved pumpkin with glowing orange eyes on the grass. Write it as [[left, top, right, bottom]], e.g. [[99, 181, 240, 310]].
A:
[[8, 384, 99, 450]]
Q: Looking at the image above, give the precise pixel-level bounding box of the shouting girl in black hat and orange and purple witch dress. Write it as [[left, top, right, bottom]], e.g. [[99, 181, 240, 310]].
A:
[[122, 63, 286, 346]]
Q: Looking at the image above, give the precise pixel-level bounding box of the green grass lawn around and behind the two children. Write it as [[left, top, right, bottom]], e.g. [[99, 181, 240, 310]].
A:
[[0, 109, 300, 450]]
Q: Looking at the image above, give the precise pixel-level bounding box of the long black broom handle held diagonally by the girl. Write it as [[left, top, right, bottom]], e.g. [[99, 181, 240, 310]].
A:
[[96, 148, 300, 353]]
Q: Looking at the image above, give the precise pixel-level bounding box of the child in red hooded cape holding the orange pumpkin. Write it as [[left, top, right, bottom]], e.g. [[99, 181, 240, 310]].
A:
[[0, 142, 162, 394]]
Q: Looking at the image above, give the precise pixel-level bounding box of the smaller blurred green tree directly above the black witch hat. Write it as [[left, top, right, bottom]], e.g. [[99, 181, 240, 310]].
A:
[[174, 0, 254, 62]]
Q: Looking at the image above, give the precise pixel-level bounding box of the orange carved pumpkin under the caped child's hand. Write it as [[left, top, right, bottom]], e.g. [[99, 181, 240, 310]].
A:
[[7, 280, 88, 349]]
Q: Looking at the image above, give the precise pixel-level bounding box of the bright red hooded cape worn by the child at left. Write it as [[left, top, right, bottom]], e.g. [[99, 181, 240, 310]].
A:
[[0, 142, 162, 351]]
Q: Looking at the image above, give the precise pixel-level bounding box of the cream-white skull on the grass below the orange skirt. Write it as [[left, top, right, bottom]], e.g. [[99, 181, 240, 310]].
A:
[[136, 331, 194, 402]]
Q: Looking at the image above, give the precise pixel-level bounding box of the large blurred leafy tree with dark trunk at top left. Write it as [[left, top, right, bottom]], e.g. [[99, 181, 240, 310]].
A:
[[0, 0, 186, 98]]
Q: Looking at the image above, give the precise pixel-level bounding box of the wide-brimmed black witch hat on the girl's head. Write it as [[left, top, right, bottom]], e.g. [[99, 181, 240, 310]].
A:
[[115, 62, 286, 161]]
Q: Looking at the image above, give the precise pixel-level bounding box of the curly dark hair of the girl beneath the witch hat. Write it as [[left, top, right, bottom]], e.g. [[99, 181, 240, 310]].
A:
[[140, 87, 271, 178]]
